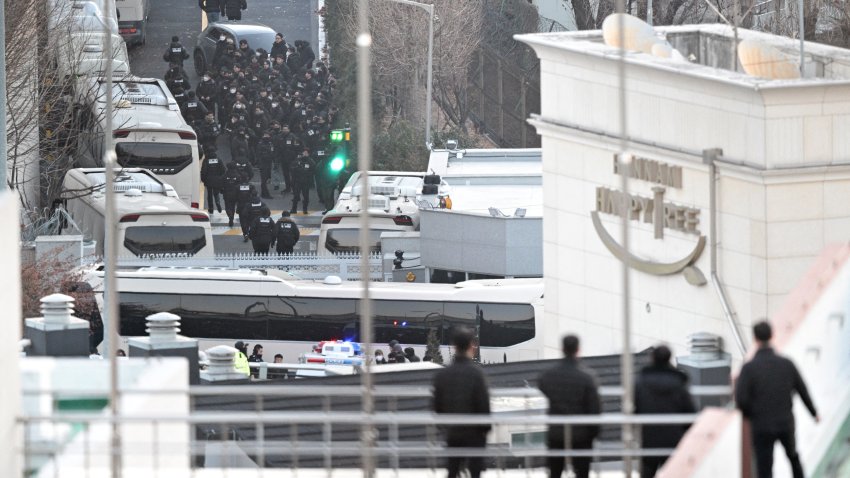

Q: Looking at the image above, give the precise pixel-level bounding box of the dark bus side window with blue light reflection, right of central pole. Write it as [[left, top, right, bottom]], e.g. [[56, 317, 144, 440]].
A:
[[372, 300, 443, 345]]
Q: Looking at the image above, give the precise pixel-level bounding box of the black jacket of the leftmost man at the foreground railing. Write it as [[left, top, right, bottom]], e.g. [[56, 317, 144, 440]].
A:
[[432, 356, 490, 446]]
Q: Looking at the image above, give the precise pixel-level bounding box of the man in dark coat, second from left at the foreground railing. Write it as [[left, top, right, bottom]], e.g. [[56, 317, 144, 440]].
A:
[[537, 335, 602, 478]]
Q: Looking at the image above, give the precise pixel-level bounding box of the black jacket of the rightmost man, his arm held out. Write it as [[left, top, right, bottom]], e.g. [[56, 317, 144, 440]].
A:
[[735, 347, 817, 431]]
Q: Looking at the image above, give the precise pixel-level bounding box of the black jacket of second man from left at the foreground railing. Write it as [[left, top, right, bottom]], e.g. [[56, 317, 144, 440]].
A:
[[537, 358, 602, 448]]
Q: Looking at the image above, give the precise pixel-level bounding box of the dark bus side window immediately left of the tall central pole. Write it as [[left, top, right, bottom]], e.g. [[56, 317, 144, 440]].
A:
[[268, 297, 360, 342]]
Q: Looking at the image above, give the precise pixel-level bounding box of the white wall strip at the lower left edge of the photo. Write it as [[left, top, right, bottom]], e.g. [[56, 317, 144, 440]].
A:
[[0, 190, 23, 476]]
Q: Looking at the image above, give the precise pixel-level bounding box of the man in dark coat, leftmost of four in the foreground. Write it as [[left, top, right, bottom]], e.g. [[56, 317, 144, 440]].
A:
[[433, 328, 490, 478]]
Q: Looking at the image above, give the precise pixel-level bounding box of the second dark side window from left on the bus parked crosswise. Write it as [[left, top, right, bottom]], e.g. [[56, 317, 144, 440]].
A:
[[174, 295, 269, 340]]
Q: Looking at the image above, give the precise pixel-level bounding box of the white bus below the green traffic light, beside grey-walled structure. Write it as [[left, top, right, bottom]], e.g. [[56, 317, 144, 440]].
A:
[[317, 171, 448, 254]]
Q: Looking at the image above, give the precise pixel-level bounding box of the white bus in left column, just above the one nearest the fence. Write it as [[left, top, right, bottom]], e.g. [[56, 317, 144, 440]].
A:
[[77, 78, 201, 208]]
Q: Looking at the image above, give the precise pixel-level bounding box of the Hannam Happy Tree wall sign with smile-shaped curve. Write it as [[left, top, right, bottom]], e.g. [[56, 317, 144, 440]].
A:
[[590, 158, 706, 285]]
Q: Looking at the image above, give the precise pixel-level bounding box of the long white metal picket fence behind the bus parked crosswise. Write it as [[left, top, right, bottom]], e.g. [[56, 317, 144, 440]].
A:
[[118, 252, 384, 281]]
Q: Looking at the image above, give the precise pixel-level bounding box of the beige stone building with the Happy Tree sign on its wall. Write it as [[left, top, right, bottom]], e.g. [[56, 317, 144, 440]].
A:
[[518, 25, 850, 358]]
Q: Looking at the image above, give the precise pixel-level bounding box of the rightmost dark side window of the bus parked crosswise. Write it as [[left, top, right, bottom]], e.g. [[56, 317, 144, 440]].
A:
[[442, 302, 534, 347]]
